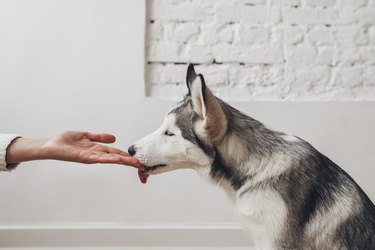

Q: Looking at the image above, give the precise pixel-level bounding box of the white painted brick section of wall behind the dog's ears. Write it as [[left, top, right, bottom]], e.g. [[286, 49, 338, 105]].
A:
[[146, 0, 375, 101]]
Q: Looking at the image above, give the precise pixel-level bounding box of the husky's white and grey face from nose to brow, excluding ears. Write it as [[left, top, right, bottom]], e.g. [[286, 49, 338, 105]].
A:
[[134, 108, 212, 177]]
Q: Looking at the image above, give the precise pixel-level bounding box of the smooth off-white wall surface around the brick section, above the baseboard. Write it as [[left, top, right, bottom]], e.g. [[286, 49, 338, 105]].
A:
[[0, 0, 375, 233]]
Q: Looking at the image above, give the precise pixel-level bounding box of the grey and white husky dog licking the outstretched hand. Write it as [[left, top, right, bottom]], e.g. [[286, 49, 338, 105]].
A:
[[128, 64, 375, 250]]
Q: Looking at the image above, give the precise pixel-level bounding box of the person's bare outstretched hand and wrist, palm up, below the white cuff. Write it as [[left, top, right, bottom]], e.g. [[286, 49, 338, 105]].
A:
[[6, 131, 142, 168]]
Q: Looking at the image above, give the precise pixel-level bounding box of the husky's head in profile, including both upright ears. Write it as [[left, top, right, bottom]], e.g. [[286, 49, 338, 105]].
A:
[[128, 64, 227, 174]]
